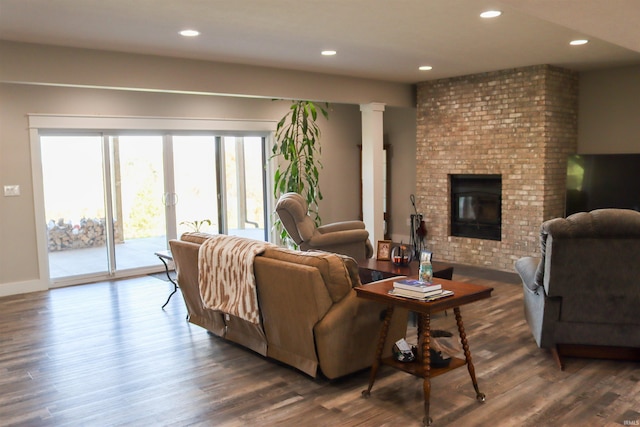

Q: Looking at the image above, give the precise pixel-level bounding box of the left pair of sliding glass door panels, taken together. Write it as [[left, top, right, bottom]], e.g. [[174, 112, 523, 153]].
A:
[[41, 135, 167, 281]]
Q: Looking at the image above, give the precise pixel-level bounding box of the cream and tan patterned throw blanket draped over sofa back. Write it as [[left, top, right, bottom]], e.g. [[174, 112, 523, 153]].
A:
[[198, 234, 273, 324]]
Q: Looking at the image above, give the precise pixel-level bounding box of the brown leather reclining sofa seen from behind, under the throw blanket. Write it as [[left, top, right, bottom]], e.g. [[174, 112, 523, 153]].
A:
[[169, 233, 408, 379]]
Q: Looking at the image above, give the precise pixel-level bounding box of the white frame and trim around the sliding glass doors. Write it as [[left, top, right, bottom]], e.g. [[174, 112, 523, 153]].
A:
[[28, 114, 277, 289]]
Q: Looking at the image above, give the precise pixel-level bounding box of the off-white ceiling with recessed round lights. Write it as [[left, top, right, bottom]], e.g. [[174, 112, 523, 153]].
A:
[[0, 0, 640, 83]]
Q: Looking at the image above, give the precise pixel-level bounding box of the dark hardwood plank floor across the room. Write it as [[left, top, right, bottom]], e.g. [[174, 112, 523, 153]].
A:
[[0, 266, 640, 426]]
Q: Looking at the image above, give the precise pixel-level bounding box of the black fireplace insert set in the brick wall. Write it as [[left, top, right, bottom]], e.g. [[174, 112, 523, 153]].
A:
[[450, 175, 502, 240]]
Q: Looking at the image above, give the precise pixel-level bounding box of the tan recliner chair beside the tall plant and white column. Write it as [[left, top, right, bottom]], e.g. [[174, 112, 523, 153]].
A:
[[276, 193, 373, 260]]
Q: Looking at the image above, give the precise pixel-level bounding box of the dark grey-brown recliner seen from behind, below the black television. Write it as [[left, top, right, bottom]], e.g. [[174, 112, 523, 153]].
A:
[[515, 209, 640, 369]]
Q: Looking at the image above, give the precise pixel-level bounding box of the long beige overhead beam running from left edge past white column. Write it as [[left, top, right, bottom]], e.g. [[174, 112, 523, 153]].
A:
[[0, 40, 415, 107]]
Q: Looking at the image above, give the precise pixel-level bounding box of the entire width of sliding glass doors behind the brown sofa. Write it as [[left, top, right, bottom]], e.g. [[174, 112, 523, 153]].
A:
[[40, 130, 268, 282]]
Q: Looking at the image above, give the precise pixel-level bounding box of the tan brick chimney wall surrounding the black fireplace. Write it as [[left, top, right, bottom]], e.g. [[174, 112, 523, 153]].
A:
[[416, 65, 578, 271]]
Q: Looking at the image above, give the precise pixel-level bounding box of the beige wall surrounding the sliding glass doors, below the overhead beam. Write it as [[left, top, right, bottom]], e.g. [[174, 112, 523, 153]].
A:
[[0, 84, 370, 290]]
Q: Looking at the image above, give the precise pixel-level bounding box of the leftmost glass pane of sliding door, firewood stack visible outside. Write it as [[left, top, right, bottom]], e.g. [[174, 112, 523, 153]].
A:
[[41, 135, 109, 279]]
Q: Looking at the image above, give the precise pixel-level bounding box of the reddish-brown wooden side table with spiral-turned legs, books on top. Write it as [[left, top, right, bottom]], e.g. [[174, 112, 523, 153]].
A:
[[354, 279, 493, 426]]
